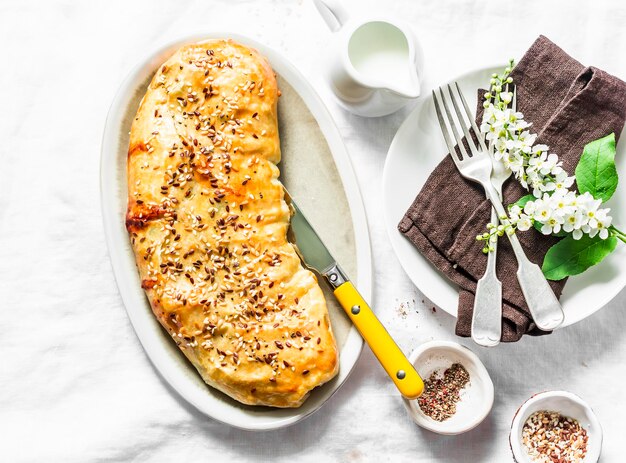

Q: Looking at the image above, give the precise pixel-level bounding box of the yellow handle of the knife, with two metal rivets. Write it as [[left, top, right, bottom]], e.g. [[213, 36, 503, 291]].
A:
[[334, 281, 424, 399]]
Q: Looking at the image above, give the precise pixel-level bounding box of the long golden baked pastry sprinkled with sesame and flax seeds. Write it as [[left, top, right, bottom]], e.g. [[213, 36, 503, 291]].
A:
[[126, 40, 338, 407]]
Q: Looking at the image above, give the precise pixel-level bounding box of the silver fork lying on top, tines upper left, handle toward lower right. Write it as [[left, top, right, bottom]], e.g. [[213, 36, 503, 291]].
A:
[[433, 83, 564, 331]]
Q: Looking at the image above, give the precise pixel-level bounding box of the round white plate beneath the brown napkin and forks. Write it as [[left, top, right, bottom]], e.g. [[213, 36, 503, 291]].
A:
[[383, 67, 626, 327]]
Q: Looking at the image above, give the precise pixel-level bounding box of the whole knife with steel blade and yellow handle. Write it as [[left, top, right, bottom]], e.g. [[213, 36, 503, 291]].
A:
[[287, 193, 424, 399]]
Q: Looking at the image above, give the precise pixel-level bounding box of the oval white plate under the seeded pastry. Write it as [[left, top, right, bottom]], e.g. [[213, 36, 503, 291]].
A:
[[100, 33, 371, 430]]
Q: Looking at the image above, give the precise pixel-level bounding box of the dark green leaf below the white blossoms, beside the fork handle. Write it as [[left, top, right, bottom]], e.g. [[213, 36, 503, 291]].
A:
[[541, 235, 617, 280]]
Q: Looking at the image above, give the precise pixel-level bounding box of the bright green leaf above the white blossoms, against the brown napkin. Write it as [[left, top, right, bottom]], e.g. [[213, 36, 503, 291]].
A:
[[576, 133, 618, 202]]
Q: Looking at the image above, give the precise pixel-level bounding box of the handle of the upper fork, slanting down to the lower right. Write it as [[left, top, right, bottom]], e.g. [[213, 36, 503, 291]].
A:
[[483, 182, 565, 331]]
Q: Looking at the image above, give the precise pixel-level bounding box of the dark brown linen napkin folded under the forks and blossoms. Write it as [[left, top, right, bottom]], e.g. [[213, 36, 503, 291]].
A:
[[398, 36, 626, 342]]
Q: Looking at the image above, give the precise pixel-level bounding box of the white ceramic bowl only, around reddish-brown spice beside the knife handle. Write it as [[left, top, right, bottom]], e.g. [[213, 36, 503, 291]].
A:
[[404, 341, 493, 435]]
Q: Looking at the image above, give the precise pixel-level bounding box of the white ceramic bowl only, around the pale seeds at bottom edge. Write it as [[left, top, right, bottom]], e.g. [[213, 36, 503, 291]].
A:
[[509, 391, 602, 463]]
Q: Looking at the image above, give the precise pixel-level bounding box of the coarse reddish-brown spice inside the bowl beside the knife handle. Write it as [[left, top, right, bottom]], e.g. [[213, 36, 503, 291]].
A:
[[417, 363, 470, 421]]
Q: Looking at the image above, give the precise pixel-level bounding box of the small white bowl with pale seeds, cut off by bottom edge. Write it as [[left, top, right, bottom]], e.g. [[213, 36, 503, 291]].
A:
[[509, 391, 602, 463]]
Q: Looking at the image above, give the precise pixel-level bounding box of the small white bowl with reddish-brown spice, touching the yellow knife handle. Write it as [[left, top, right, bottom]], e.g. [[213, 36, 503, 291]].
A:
[[404, 341, 493, 435]]
